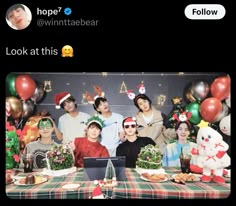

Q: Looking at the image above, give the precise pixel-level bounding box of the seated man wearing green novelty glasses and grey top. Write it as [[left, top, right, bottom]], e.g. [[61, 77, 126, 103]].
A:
[[23, 117, 57, 168]]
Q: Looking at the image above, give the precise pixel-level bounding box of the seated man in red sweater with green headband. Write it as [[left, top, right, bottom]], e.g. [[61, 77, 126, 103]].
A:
[[73, 116, 109, 167]]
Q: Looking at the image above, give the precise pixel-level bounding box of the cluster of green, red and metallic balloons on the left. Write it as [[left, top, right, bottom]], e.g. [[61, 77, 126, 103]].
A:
[[6, 73, 46, 120]]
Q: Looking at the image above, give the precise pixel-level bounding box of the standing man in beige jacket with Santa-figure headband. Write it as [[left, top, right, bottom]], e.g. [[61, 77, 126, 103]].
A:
[[133, 94, 172, 153]]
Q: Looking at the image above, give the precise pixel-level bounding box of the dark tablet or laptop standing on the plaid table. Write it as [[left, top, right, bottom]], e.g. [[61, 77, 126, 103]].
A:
[[83, 156, 127, 181]]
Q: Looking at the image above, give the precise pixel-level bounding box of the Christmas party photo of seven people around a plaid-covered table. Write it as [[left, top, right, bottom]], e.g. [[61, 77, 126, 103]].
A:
[[5, 72, 231, 199]]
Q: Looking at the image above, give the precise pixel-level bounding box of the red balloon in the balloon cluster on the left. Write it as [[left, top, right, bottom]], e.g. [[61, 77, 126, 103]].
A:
[[15, 75, 36, 100]]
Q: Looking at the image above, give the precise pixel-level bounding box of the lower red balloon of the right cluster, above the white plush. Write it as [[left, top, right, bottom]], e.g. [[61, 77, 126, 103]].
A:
[[200, 97, 222, 122]]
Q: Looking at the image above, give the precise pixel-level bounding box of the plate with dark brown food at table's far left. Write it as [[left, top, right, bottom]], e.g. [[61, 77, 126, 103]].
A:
[[14, 175, 48, 186]]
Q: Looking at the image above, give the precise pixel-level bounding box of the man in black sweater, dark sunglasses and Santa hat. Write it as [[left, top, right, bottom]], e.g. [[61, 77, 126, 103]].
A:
[[116, 117, 156, 168]]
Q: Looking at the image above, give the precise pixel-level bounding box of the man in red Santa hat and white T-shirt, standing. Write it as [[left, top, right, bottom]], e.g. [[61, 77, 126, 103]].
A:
[[54, 92, 91, 143]]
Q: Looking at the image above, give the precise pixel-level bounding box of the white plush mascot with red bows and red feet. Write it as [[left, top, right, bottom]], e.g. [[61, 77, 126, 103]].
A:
[[194, 127, 230, 183]]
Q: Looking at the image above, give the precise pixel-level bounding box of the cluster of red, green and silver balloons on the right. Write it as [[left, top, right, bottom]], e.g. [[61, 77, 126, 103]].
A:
[[182, 76, 230, 125]]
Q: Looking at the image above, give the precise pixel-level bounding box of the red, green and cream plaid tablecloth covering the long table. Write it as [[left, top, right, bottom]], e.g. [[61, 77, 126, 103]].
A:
[[6, 168, 231, 199]]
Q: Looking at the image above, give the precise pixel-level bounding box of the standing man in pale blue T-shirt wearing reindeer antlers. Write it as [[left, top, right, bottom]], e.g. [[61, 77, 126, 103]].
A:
[[93, 96, 125, 157]]
